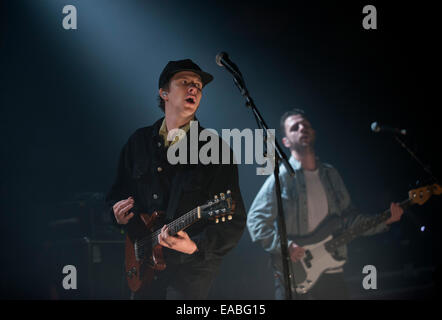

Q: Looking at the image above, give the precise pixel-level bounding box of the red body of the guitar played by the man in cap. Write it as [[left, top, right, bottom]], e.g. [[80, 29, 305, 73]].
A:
[[125, 211, 166, 292]]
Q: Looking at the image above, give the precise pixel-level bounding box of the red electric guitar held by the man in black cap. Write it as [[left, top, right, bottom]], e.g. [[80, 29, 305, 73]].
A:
[[125, 190, 234, 292]]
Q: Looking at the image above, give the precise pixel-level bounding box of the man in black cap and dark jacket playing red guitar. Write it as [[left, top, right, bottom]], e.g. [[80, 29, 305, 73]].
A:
[[106, 59, 246, 299]]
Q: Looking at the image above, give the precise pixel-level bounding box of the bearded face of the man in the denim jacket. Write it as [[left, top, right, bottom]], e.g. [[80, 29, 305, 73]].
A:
[[282, 115, 315, 150]]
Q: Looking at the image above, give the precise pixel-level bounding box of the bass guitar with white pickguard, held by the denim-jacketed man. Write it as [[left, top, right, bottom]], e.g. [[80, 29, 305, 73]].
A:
[[291, 184, 442, 294]]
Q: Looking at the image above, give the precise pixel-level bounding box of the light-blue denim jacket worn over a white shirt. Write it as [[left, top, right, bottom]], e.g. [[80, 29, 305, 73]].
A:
[[247, 156, 388, 258]]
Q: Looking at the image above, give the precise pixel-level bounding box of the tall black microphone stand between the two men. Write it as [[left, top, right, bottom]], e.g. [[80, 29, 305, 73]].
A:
[[227, 66, 296, 300]]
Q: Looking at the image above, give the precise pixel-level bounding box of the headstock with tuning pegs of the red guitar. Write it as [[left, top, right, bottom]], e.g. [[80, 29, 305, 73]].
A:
[[200, 190, 233, 223]]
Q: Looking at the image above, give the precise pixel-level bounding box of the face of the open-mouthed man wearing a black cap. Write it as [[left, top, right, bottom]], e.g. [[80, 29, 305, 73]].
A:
[[165, 71, 203, 118]]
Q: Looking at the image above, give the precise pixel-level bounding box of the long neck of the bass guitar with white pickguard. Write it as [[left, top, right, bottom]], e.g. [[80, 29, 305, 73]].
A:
[[325, 199, 413, 252]]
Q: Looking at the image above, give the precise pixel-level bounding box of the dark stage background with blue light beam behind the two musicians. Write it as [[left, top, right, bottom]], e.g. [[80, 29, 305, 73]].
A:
[[0, 0, 442, 299]]
